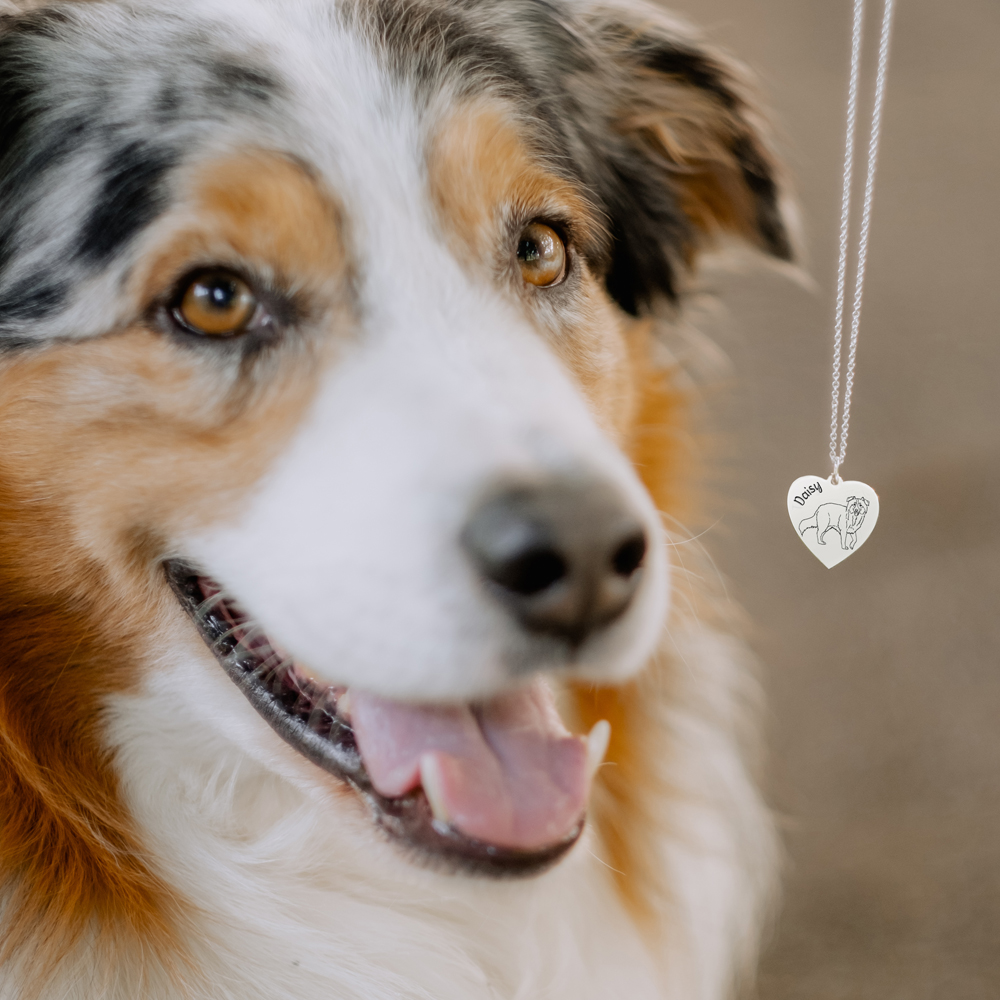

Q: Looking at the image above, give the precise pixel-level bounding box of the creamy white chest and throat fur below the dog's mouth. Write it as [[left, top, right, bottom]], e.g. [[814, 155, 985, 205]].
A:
[[90, 584, 774, 1000]]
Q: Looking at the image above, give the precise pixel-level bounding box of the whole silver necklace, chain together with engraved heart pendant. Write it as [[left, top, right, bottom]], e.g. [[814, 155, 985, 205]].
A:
[[788, 0, 895, 568]]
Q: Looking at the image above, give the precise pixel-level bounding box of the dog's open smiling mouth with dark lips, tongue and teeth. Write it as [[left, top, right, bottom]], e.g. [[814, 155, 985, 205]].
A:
[[165, 560, 608, 877]]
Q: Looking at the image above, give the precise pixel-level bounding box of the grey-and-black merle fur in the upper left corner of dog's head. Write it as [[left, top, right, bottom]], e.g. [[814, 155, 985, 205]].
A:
[[0, 5, 284, 340]]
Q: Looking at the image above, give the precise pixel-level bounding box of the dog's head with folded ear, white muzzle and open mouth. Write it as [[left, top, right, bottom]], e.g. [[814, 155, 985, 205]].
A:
[[0, 0, 788, 920]]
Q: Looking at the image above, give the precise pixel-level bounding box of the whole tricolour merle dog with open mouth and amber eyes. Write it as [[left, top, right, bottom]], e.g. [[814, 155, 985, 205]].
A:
[[0, 0, 788, 1000]]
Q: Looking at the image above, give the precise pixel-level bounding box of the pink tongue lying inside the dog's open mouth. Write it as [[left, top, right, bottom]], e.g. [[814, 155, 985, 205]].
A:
[[350, 681, 588, 850]]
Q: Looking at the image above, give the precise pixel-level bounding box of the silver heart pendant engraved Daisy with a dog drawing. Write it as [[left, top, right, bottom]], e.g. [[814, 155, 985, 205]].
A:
[[788, 476, 878, 569]]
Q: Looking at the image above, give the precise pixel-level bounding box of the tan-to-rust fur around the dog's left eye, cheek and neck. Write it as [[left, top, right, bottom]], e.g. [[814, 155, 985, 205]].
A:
[[0, 157, 343, 988]]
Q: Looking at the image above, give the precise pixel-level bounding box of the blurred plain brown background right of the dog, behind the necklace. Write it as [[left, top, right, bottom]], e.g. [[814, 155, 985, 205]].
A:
[[668, 0, 1000, 1000]]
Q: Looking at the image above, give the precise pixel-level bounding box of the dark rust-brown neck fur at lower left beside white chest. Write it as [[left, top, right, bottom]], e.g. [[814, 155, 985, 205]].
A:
[[0, 496, 183, 997]]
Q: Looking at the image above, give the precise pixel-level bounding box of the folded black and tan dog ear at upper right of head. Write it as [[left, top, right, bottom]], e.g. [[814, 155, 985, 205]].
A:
[[583, 2, 793, 314]]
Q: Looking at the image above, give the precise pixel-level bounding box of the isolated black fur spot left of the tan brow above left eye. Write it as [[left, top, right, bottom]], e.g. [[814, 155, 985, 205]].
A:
[[78, 140, 180, 265]]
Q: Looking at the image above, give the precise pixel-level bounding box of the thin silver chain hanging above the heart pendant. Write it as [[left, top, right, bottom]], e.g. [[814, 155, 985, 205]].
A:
[[830, 0, 895, 483]]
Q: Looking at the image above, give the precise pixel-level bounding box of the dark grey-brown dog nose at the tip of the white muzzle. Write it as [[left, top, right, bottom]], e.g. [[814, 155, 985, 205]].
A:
[[462, 479, 647, 646]]
